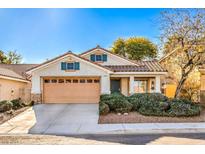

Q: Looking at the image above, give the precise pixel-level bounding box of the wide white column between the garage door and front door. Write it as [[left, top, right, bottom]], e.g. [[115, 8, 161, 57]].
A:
[[100, 75, 110, 94]]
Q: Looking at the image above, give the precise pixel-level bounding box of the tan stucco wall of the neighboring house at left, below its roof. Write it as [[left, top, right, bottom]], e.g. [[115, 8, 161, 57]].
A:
[[0, 78, 31, 101]]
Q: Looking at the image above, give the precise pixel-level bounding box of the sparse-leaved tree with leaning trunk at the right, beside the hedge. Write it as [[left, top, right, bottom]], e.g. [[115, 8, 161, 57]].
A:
[[160, 9, 205, 98]]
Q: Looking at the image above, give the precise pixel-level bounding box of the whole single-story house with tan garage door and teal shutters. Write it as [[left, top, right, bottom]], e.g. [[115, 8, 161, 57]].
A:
[[26, 46, 167, 103]]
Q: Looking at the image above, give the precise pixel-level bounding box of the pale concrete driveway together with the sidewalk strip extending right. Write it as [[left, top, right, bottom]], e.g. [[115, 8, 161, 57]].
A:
[[0, 104, 205, 135]]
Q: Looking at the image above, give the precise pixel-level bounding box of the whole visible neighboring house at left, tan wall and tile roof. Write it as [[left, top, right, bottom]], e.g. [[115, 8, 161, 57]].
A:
[[0, 64, 36, 101]]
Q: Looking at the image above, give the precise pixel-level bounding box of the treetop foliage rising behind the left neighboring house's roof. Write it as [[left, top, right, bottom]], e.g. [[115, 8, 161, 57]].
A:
[[0, 50, 22, 64]]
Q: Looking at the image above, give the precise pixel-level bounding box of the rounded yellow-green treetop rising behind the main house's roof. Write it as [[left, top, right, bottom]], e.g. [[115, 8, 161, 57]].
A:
[[111, 37, 157, 60]]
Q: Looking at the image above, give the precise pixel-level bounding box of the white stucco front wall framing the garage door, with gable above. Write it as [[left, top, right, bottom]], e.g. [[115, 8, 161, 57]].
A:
[[31, 56, 110, 94]]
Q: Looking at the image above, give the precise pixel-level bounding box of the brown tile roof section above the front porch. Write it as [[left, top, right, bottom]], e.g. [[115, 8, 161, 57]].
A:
[[104, 60, 167, 72]]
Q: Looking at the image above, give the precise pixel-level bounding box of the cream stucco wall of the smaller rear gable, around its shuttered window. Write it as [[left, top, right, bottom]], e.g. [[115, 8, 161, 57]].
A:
[[83, 49, 133, 65]]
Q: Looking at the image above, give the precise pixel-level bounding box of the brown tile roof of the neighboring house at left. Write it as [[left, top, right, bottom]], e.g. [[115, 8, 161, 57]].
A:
[[0, 64, 37, 80]]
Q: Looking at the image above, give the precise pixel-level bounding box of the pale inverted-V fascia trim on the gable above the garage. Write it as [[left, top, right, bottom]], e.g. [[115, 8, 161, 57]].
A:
[[26, 54, 112, 74]]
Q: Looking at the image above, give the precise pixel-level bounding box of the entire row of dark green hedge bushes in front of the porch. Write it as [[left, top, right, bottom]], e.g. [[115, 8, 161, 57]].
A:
[[100, 93, 201, 117]]
